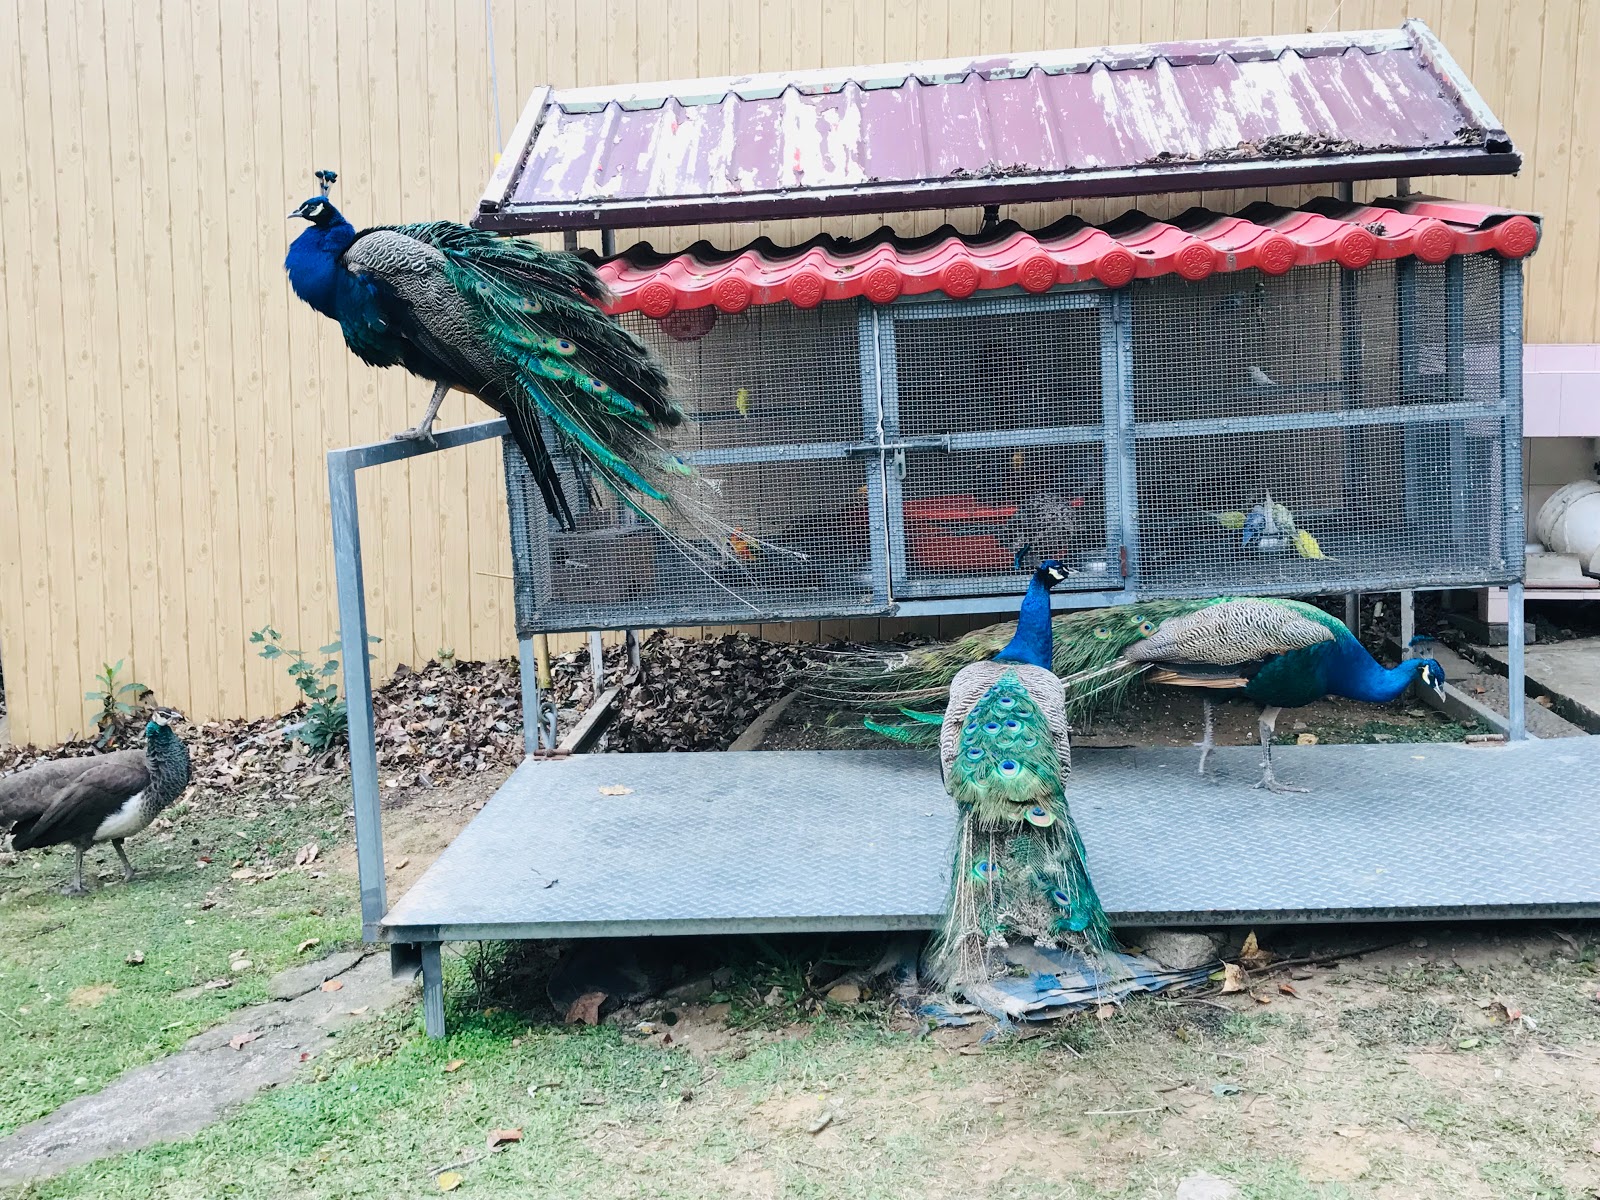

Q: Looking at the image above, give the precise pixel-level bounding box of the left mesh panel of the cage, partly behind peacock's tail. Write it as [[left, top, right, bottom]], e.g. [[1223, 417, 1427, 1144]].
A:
[[506, 304, 886, 634]]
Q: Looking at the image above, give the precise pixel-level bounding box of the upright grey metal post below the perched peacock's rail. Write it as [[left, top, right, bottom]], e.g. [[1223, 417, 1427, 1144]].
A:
[[328, 450, 389, 941]]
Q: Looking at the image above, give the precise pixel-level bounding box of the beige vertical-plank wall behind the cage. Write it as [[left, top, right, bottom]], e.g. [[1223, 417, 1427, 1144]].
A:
[[0, 0, 1600, 741]]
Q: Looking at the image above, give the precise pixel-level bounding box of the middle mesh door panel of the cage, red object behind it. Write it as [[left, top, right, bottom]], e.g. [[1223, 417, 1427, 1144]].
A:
[[886, 293, 1122, 597]]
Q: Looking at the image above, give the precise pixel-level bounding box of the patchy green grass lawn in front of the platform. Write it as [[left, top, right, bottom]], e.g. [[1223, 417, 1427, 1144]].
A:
[[0, 784, 1600, 1200]]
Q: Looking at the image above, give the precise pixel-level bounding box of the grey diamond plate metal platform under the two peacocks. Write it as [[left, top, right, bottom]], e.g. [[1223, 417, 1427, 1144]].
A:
[[382, 738, 1600, 942]]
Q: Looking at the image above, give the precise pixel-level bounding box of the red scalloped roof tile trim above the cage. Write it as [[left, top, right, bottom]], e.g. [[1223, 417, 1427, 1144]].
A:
[[600, 197, 1539, 320]]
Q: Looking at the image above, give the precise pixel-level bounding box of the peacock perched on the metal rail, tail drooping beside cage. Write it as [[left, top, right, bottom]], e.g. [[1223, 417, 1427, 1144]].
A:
[[283, 171, 761, 557]]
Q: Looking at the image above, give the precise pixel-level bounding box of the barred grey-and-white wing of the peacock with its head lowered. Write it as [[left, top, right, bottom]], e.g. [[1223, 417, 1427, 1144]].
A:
[[1123, 597, 1334, 667]]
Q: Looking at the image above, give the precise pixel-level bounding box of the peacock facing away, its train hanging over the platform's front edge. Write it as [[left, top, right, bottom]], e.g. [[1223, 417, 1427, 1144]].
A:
[[869, 560, 1115, 990]]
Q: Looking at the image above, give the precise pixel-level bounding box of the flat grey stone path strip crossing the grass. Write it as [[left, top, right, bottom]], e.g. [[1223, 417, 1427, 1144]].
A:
[[0, 954, 410, 1187]]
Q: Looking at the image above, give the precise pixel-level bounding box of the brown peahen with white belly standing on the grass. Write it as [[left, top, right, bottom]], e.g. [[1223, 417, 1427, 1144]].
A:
[[0, 709, 189, 896]]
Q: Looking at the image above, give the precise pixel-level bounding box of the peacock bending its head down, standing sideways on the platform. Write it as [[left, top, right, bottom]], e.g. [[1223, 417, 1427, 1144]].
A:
[[806, 597, 1445, 792]]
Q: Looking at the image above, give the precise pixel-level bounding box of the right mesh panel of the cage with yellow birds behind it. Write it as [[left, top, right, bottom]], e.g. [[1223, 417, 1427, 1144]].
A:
[[1133, 256, 1520, 595]]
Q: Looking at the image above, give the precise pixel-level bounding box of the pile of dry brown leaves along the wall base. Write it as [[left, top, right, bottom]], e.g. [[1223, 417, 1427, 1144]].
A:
[[0, 630, 808, 795]]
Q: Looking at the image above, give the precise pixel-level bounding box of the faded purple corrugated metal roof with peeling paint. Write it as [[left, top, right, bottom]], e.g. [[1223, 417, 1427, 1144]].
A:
[[475, 21, 1520, 230]]
